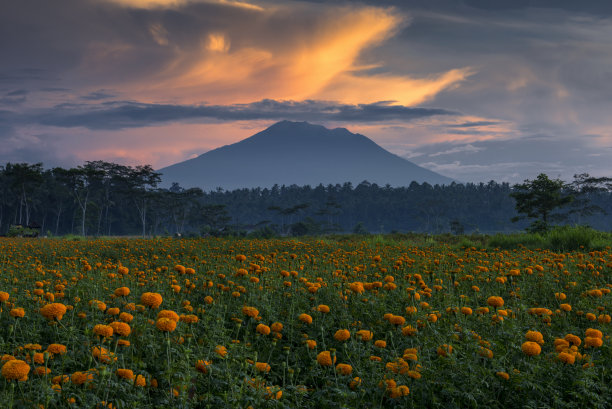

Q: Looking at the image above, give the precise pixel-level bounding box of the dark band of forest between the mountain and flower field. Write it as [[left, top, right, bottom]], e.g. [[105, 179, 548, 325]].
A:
[[0, 161, 612, 237]]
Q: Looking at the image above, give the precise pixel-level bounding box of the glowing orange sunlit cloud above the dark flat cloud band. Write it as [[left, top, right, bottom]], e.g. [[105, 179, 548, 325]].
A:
[[100, 0, 472, 105]]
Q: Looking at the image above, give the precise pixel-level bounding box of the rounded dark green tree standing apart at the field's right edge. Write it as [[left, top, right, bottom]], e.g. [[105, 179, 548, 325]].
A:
[[510, 173, 574, 232]]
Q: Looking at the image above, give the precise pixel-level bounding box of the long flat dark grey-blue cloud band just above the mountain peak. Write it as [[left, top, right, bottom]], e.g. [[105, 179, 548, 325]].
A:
[[25, 99, 459, 130]]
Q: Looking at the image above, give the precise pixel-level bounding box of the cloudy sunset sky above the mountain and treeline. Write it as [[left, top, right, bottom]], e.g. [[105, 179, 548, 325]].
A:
[[0, 0, 612, 183]]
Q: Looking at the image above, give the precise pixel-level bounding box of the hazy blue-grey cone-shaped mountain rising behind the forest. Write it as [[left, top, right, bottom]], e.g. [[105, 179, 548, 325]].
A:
[[159, 121, 452, 191]]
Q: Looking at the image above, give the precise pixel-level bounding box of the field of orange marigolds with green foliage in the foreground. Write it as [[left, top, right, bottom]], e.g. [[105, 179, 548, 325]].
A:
[[0, 239, 612, 409]]
